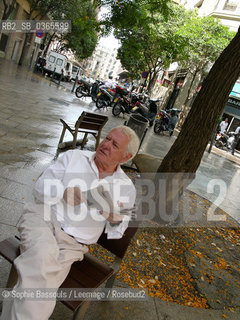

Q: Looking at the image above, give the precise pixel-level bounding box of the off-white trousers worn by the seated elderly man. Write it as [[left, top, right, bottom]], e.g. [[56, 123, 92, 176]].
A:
[[1, 204, 88, 320]]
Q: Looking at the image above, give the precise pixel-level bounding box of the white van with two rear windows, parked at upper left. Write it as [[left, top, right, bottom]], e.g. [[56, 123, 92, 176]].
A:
[[43, 51, 72, 80]]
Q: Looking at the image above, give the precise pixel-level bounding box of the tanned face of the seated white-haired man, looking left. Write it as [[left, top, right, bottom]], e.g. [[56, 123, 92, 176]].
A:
[[95, 129, 131, 166]]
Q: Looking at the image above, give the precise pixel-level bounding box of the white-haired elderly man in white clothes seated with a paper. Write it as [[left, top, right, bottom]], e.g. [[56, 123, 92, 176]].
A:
[[1, 126, 139, 320]]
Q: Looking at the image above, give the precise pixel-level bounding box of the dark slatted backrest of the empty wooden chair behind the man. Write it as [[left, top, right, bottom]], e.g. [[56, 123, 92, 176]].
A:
[[75, 111, 108, 131]]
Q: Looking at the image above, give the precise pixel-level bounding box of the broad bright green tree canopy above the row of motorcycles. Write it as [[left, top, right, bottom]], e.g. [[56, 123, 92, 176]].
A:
[[105, 0, 234, 92]]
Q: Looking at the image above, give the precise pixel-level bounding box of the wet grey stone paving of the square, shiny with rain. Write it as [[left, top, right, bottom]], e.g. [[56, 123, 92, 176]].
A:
[[0, 59, 240, 319]]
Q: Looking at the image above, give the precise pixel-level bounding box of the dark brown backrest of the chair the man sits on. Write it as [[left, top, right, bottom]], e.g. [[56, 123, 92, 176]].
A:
[[97, 221, 138, 259]]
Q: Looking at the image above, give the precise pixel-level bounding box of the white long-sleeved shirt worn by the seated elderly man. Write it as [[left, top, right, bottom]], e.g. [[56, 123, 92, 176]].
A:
[[34, 150, 136, 244]]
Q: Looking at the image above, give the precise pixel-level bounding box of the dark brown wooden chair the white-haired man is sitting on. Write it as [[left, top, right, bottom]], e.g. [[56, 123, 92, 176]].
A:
[[0, 221, 137, 320]]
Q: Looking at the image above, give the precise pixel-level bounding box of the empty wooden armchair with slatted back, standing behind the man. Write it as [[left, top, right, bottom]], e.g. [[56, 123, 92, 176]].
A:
[[58, 111, 108, 150]]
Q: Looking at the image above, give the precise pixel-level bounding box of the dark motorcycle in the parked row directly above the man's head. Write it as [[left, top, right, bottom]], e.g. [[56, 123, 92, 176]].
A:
[[112, 86, 142, 117]]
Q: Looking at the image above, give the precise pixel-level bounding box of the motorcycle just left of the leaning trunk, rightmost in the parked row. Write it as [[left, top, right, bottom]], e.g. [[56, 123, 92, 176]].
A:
[[153, 109, 181, 136]]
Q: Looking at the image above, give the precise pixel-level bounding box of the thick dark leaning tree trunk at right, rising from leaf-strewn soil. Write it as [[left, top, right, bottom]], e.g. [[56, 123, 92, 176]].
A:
[[153, 28, 240, 224]]
